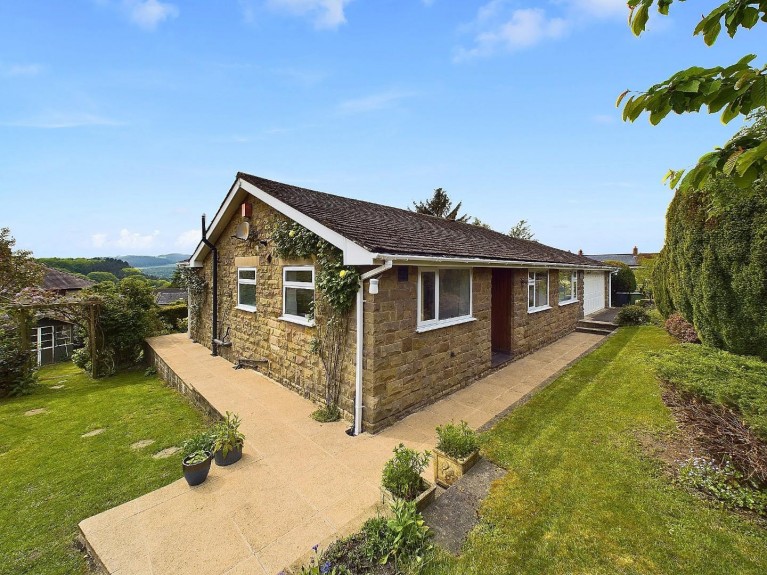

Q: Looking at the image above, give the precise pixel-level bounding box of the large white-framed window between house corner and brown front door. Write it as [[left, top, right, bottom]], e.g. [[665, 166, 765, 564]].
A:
[[418, 268, 474, 331]]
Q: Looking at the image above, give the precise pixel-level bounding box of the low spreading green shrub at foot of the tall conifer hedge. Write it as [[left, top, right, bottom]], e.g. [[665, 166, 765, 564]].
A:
[[653, 344, 767, 441]]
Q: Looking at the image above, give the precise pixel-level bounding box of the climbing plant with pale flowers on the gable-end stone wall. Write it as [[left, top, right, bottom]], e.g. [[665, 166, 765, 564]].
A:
[[271, 221, 360, 421]]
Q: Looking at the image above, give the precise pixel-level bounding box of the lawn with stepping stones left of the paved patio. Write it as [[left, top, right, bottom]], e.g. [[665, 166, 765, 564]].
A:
[[0, 364, 204, 575]]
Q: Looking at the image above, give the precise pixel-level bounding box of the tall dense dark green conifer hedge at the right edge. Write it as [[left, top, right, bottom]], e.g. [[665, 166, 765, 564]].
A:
[[653, 178, 767, 360]]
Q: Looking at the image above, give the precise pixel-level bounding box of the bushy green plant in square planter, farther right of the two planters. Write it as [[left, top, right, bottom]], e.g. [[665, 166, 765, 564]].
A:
[[434, 421, 479, 489]]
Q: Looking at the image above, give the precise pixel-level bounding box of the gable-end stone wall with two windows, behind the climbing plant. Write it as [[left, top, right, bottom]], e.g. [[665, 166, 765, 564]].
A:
[[191, 197, 356, 416]]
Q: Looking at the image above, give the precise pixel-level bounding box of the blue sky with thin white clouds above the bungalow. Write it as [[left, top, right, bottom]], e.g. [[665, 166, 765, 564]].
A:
[[0, 0, 765, 256]]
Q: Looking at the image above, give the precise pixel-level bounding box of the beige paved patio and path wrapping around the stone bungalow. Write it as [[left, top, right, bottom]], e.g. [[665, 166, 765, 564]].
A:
[[80, 333, 602, 575]]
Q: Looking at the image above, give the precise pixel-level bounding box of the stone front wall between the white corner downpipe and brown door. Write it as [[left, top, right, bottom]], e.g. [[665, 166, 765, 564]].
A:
[[363, 267, 492, 431]]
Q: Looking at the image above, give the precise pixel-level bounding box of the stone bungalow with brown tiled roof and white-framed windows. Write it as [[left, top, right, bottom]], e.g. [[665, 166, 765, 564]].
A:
[[189, 173, 610, 433]]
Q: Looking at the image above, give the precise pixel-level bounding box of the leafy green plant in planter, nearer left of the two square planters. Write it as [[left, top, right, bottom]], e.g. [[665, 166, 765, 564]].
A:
[[381, 443, 437, 511]]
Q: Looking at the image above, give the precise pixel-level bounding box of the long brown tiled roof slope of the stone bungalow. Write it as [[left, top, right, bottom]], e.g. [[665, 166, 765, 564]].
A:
[[237, 172, 603, 266]]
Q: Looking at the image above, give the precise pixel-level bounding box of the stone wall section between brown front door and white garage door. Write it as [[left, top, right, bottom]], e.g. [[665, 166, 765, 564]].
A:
[[511, 269, 583, 358]]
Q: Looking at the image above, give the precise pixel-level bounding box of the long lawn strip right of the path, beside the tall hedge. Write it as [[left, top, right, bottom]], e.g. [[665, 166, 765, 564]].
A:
[[426, 327, 767, 575]]
